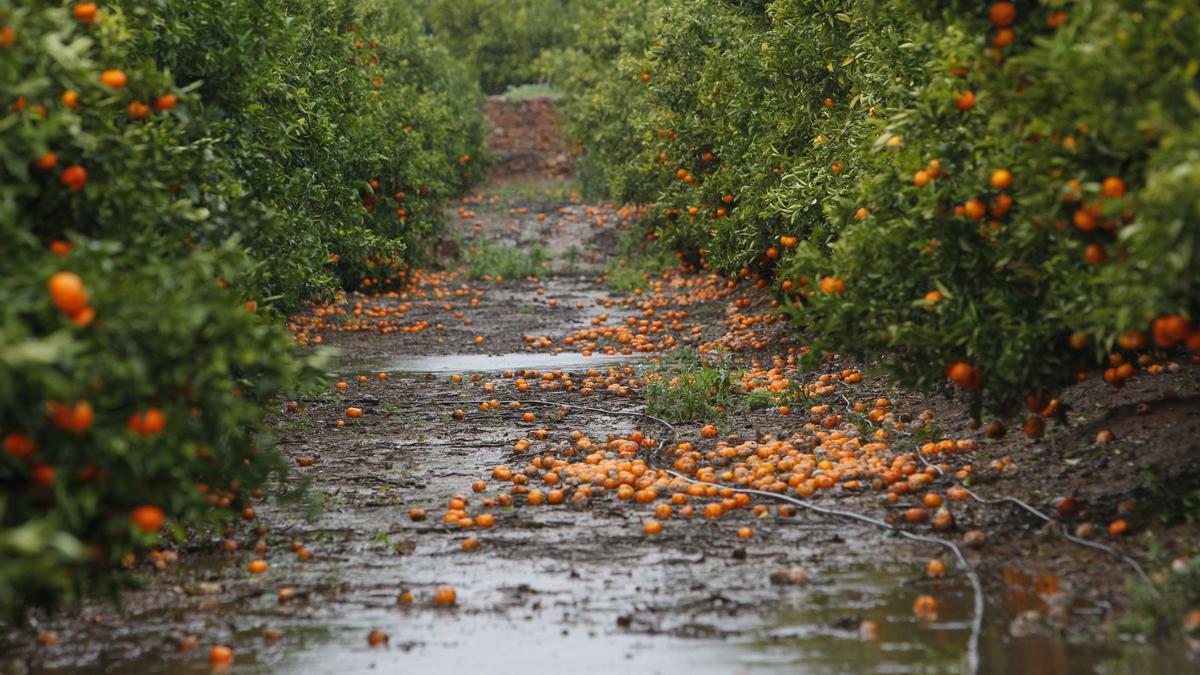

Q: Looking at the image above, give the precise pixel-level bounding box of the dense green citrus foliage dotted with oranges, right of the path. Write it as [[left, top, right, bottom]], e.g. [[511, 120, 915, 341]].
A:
[[549, 0, 1200, 412]]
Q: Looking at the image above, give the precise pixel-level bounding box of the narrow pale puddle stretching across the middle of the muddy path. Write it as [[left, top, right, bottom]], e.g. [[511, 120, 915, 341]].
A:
[[355, 352, 653, 374]]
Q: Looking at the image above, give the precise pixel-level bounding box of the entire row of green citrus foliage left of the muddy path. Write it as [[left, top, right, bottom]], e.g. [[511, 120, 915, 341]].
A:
[[0, 0, 482, 613]]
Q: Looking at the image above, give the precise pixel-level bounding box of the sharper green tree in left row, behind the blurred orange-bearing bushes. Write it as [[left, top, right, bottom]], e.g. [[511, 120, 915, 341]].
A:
[[112, 0, 486, 300]]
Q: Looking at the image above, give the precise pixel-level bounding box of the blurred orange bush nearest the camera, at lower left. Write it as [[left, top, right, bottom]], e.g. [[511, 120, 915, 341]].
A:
[[0, 241, 320, 611]]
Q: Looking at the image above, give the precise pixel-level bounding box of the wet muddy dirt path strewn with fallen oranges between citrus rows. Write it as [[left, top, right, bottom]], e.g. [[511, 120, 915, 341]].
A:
[[4, 97, 1200, 673]]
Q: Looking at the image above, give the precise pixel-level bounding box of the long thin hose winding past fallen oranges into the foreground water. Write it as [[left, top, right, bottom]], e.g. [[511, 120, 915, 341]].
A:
[[434, 399, 984, 675]]
